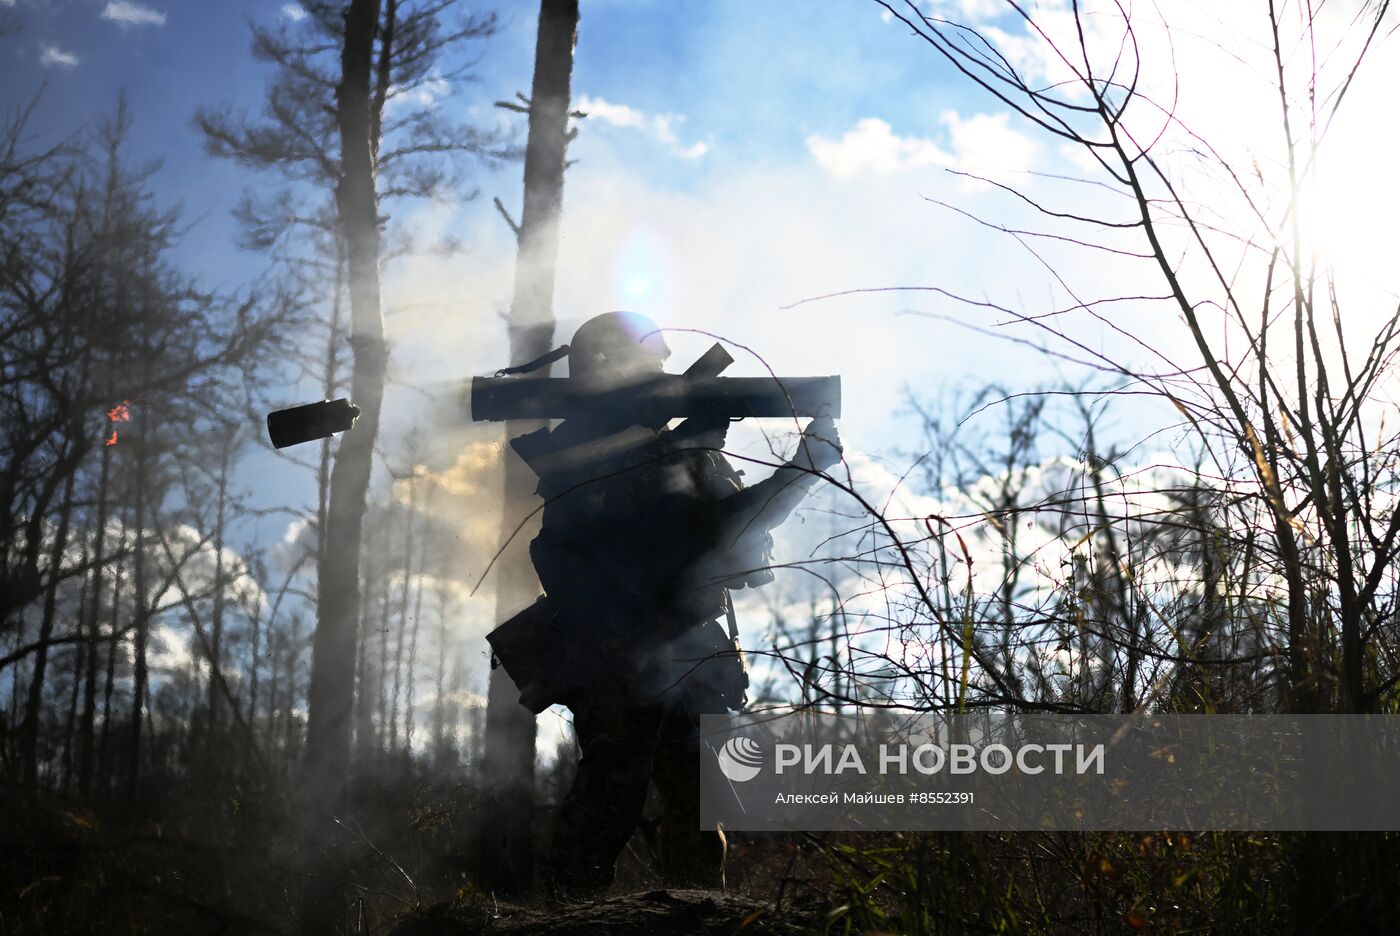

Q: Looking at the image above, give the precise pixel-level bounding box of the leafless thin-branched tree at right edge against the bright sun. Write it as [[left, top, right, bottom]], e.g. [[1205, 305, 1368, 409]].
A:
[[881, 0, 1400, 928]]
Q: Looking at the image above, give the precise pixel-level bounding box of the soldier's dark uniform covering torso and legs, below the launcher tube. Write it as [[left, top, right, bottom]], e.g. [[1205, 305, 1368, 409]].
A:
[[531, 423, 767, 893]]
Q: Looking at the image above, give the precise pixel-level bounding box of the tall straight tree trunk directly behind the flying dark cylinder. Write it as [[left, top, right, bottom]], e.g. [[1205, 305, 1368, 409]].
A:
[[301, 0, 391, 933]]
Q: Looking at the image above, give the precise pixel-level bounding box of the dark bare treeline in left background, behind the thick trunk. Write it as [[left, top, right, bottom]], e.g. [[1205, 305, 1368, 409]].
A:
[[0, 87, 498, 932]]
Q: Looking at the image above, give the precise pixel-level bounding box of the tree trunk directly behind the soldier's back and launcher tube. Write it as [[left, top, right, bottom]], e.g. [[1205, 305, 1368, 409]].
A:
[[477, 0, 578, 891]]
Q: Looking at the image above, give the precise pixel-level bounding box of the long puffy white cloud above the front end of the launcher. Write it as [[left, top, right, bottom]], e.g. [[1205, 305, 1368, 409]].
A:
[[806, 111, 1037, 187]]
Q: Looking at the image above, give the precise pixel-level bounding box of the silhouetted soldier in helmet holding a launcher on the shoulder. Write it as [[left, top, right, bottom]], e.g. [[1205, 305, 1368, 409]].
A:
[[495, 312, 840, 895]]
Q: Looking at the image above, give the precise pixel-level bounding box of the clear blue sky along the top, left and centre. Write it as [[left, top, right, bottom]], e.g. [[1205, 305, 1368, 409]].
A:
[[0, 0, 985, 283]]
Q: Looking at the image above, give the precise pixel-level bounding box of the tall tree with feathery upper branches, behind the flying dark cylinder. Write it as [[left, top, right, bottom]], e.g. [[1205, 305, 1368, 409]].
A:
[[196, 0, 501, 929]]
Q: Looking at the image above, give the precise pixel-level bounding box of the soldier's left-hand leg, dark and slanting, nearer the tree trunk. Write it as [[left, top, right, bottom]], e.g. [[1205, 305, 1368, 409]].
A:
[[550, 702, 658, 895]]
